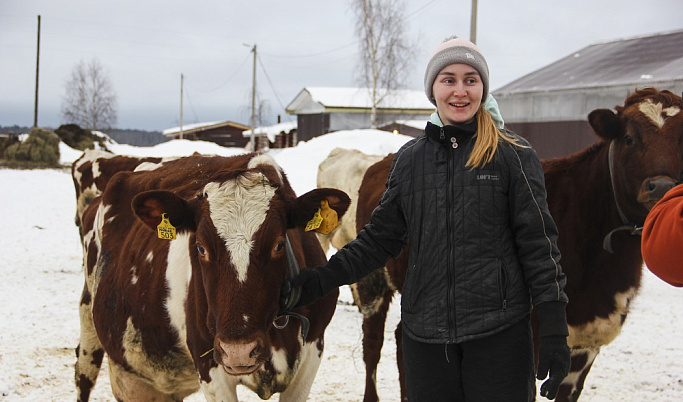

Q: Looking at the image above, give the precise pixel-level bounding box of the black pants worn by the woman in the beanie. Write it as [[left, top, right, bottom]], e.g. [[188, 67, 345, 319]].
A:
[[403, 317, 535, 402]]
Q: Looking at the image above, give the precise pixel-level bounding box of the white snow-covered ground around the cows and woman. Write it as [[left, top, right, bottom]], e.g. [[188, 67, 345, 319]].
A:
[[0, 130, 683, 402]]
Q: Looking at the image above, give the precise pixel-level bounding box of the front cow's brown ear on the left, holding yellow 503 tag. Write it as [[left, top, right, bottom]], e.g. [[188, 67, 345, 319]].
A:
[[131, 190, 193, 230]]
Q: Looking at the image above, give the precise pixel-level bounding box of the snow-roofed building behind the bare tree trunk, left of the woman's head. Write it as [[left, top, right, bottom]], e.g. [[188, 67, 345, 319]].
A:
[[285, 87, 434, 141]]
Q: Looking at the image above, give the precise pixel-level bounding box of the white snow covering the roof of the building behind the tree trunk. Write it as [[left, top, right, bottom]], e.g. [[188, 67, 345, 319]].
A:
[[286, 87, 434, 113]]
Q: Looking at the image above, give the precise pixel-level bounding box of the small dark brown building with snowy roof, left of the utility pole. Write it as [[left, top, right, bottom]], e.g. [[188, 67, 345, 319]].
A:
[[162, 121, 249, 148]]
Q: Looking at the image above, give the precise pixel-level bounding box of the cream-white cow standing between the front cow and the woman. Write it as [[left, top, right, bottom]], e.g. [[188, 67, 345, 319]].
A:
[[316, 148, 384, 252]]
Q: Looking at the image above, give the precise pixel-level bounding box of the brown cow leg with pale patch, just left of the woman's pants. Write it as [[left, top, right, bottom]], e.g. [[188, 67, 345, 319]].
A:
[[357, 270, 394, 402]]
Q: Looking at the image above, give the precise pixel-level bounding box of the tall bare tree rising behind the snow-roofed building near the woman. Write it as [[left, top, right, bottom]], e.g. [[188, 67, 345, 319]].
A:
[[351, 0, 416, 128]]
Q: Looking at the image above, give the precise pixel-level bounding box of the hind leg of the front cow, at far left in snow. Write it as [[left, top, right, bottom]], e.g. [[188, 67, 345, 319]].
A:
[[75, 285, 104, 402]]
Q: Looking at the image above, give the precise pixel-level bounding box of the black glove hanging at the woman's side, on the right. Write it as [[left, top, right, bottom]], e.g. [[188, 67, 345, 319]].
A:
[[536, 335, 570, 399]]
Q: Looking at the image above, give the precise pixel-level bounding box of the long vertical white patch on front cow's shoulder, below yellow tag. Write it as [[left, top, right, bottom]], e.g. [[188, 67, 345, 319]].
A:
[[166, 233, 192, 348]]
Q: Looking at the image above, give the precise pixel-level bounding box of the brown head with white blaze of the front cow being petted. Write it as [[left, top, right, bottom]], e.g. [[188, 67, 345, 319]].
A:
[[132, 155, 349, 375]]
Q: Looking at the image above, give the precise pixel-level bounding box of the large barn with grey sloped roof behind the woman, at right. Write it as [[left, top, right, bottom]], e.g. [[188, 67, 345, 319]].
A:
[[493, 31, 683, 158]]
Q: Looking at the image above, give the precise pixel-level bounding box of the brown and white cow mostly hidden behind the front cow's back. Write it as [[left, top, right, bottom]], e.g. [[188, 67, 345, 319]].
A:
[[71, 149, 162, 231]]
